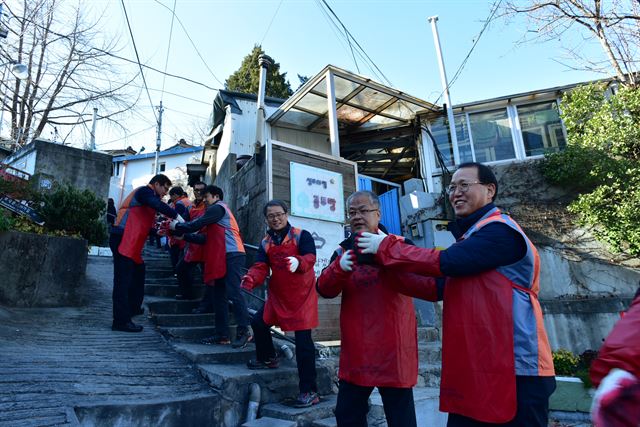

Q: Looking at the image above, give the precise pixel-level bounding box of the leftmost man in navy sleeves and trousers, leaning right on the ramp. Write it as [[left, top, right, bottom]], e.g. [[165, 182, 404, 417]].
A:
[[109, 174, 184, 332]]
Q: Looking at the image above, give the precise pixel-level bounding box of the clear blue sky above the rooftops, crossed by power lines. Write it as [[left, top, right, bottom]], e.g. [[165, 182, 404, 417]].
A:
[[88, 0, 602, 151]]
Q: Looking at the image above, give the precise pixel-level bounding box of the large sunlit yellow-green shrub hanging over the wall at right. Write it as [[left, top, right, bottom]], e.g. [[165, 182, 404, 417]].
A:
[[542, 84, 640, 255]]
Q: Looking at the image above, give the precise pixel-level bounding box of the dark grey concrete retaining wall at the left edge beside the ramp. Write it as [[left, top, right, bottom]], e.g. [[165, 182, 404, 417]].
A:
[[0, 231, 87, 307]]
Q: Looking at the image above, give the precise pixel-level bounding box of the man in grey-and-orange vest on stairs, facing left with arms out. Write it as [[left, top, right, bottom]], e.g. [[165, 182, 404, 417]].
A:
[[169, 185, 253, 348]]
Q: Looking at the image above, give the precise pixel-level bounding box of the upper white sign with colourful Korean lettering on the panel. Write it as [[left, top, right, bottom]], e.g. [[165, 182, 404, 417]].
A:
[[290, 162, 344, 223]]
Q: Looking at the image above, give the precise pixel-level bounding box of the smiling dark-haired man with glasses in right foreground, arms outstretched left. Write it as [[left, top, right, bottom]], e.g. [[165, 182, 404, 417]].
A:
[[357, 163, 555, 427]]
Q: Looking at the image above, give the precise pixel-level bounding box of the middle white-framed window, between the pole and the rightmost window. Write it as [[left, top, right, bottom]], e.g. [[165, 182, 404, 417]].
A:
[[469, 108, 516, 163]]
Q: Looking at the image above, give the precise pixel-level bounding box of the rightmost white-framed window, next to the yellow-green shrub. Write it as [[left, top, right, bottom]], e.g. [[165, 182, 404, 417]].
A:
[[517, 101, 567, 157]]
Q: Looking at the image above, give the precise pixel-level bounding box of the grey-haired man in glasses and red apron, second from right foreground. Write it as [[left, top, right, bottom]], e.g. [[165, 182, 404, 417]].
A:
[[317, 191, 437, 427]]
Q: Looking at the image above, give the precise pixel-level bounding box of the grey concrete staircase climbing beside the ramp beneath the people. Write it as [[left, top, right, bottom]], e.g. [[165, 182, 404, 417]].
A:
[[139, 246, 446, 427]]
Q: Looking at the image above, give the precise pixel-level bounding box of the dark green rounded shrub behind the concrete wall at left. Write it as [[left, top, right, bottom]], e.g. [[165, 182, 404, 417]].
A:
[[36, 185, 107, 244]]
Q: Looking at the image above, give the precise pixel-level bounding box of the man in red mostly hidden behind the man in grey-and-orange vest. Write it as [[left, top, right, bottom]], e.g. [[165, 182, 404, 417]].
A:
[[176, 181, 206, 300]]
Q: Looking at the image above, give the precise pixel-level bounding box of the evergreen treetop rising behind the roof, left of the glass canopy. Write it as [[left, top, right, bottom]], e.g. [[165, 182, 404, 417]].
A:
[[224, 45, 293, 99]]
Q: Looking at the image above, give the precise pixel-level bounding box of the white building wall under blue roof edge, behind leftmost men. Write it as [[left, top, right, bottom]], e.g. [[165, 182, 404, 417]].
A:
[[109, 151, 202, 206]]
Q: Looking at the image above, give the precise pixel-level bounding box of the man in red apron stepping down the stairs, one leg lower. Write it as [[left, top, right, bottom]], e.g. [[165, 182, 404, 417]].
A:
[[241, 200, 320, 407]]
